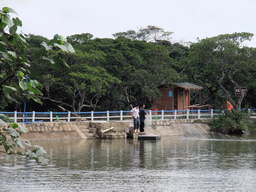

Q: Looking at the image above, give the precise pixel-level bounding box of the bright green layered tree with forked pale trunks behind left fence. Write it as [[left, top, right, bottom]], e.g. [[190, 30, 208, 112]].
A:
[[32, 34, 120, 112]]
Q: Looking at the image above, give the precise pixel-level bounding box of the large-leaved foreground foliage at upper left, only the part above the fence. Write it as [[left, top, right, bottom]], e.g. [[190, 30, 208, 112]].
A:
[[0, 7, 74, 109]]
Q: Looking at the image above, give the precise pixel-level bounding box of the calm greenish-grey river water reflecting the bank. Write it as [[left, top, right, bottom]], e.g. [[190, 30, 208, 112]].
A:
[[0, 135, 256, 192]]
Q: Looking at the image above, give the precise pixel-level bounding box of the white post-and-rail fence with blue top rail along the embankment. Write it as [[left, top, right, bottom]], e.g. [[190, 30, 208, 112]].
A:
[[0, 109, 256, 123]]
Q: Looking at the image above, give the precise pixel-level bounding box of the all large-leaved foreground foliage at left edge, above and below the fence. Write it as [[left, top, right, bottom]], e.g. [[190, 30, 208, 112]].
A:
[[0, 7, 74, 163]]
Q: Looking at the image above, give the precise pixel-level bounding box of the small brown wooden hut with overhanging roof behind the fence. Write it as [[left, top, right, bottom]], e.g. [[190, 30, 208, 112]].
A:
[[153, 83, 203, 110]]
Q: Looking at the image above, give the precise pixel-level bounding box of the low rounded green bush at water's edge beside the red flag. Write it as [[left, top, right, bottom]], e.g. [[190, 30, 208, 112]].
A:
[[209, 110, 256, 134]]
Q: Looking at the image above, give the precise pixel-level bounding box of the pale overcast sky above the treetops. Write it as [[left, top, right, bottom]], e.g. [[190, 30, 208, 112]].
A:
[[0, 0, 256, 47]]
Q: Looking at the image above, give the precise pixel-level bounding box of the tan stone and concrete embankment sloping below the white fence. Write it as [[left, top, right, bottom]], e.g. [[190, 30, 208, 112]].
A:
[[21, 120, 209, 141]]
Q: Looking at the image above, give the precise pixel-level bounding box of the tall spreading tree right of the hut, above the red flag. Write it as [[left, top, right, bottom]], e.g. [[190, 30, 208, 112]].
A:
[[187, 33, 255, 109]]
